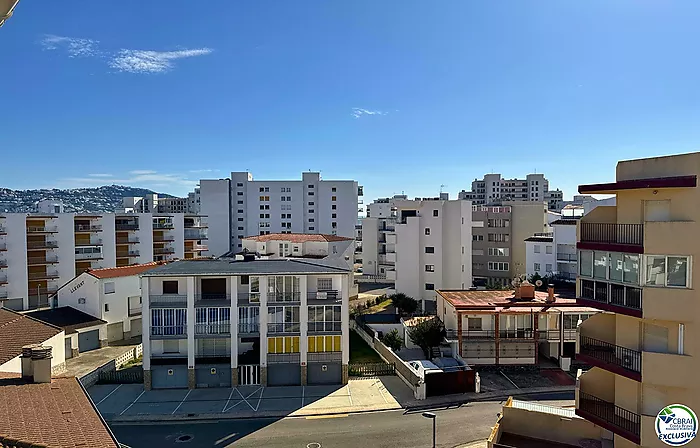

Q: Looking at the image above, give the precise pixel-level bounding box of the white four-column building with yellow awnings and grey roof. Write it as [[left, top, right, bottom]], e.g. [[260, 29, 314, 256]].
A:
[[141, 257, 352, 389]]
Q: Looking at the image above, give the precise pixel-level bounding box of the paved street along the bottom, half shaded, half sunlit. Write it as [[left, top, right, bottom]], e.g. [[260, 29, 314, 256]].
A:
[[112, 394, 572, 448]]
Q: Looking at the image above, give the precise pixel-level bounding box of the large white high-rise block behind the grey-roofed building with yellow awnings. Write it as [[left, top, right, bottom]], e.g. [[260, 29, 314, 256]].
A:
[[199, 172, 362, 256]]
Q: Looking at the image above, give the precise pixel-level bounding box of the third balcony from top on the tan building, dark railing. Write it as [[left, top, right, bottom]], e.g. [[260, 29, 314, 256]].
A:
[[576, 335, 642, 381]]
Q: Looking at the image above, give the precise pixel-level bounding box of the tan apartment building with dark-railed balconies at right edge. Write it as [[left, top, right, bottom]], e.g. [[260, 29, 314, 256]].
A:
[[576, 153, 700, 447]]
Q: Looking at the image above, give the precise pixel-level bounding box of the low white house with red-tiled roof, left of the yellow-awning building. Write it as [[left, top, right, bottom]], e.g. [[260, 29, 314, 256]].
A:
[[54, 263, 159, 343]]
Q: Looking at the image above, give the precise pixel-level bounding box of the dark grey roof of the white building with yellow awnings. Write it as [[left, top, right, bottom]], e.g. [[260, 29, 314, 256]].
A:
[[142, 258, 351, 277]]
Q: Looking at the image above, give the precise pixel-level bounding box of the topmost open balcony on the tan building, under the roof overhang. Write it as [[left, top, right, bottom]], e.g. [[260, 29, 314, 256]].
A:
[[576, 222, 644, 254]]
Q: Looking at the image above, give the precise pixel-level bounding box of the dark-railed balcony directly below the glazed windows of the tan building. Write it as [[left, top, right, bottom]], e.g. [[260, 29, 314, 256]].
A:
[[576, 279, 642, 317]]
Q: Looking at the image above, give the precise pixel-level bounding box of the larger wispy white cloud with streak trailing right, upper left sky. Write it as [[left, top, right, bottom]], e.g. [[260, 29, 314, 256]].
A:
[[109, 48, 213, 73]]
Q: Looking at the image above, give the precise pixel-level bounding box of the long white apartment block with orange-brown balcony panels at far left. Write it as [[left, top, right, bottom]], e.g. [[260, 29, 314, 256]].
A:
[[0, 213, 207, 310]]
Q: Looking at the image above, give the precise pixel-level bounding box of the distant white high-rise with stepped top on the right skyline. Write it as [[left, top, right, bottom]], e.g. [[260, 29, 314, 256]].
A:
[[458, 174, 564, 211]]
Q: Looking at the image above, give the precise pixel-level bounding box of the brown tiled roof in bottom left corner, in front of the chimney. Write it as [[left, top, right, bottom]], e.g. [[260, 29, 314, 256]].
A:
[[0, 374, 119, 448]]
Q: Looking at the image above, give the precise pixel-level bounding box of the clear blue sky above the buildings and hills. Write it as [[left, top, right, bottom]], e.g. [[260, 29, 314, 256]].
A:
[[0, 0, 700, 199]]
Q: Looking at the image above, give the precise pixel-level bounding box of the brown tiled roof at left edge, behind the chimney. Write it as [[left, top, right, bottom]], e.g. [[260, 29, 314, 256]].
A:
[[0, 308, 61, 366]]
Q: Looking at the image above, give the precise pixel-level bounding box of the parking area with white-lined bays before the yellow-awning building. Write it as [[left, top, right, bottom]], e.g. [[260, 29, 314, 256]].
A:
[[88, 377, 400, 421]]
